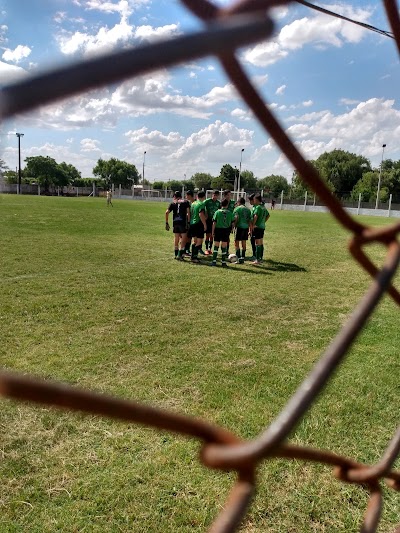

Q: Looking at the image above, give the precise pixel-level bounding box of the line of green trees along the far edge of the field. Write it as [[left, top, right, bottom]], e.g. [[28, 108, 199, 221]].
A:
[[0, 150, 400, 202]]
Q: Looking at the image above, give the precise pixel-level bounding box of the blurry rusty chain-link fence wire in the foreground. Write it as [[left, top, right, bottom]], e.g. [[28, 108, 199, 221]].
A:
[[0, 0, 400, 533]]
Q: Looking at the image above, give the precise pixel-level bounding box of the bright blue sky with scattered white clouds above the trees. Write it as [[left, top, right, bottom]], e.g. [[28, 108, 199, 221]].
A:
[[0, 0, 400, 181]]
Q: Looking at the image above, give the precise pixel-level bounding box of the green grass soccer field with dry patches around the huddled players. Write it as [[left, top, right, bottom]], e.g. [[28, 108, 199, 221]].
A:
[[0, 196, 400, 533]]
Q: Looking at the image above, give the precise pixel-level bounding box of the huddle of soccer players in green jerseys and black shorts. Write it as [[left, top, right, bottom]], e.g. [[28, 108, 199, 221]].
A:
[[165, 190, 270, 267]]
